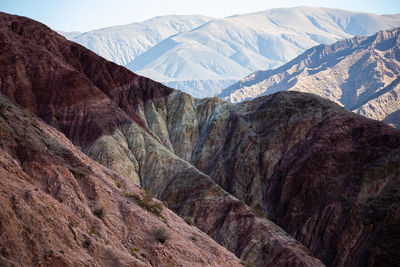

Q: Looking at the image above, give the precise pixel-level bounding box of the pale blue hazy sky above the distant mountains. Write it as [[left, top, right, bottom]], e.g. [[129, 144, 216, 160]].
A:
[[0, 0, 400, 31]]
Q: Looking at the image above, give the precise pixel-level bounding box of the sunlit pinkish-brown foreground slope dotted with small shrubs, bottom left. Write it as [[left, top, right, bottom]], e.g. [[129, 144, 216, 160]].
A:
[[0, 95, 241, 266]]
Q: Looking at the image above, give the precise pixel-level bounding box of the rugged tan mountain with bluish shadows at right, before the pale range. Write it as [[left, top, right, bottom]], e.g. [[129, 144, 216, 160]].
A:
[[219, 28, 400, 130]]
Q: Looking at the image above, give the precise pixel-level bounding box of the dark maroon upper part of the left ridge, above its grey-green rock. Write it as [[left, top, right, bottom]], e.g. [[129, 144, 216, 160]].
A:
[[0, 13, 172, 148]]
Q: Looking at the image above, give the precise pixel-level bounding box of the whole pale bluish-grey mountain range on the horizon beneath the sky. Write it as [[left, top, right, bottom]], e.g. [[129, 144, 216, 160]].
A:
[[64, 7, 400, 97]]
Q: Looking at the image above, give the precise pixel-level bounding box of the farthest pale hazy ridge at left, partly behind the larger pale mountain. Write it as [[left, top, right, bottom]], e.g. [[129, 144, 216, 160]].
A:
[[67, 15, 211, 65]]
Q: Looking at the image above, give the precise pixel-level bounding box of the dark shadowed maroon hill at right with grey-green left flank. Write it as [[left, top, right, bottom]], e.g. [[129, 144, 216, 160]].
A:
[[145, 92, 400, 266]]
